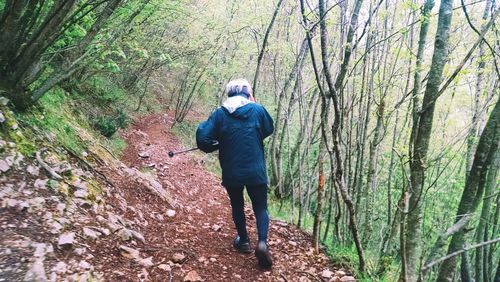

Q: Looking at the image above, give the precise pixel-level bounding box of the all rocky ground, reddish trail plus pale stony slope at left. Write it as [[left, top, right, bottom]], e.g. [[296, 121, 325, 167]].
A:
[[0, 111, 355, 281]]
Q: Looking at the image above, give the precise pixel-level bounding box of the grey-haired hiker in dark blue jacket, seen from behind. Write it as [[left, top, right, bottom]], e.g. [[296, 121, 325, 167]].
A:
[[196, 79, 274, 269]]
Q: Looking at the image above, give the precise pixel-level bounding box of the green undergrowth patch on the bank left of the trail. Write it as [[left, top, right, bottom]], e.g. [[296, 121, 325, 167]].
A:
[[11, 76, 161, 157]]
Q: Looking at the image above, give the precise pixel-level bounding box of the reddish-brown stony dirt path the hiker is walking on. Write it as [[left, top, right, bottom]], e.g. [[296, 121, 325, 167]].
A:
[[97, 115, 352, 281]]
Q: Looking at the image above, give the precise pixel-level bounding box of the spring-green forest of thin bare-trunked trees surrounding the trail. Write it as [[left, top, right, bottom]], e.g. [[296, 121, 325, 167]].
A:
[[0, 0, 500, 281]]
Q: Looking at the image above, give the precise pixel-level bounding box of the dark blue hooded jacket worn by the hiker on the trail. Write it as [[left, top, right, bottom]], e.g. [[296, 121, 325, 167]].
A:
[[196, 97, 274, 187]]
